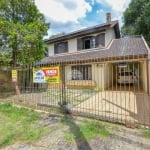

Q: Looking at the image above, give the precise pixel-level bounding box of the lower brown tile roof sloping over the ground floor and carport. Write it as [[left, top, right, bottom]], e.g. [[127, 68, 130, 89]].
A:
[[39, 37, 149, 64]]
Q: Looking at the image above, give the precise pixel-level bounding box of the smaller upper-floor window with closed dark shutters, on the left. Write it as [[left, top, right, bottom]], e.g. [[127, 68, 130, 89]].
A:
[[54, 42, 68, 54]]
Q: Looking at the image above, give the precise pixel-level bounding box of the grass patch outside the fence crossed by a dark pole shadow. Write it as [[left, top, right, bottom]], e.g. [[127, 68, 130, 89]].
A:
[[61, 116, 110, 143]]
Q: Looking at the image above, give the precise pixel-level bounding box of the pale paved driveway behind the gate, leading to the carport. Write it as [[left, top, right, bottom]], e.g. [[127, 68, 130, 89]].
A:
[[73, 91, 150, 125]]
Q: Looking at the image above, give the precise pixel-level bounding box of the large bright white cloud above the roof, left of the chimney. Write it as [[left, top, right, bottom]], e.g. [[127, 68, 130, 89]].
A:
[[35, 0, 92, 23]]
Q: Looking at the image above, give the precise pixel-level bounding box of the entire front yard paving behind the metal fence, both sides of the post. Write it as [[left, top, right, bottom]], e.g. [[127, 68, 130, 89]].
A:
[[1, 90, 150, 125]]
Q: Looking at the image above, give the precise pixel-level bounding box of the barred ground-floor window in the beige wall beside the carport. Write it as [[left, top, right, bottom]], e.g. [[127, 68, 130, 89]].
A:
[[71, 65, 92, 80]]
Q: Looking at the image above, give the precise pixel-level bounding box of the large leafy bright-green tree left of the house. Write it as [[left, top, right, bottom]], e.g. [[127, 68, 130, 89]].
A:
[[0, 0, 49, 66]]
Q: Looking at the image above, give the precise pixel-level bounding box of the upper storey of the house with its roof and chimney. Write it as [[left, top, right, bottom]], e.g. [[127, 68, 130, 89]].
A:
[[46, 14, 120, 56]]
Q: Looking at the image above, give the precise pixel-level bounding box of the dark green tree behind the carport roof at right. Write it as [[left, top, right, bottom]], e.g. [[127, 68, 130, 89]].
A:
[[121, 0, 150, 45]]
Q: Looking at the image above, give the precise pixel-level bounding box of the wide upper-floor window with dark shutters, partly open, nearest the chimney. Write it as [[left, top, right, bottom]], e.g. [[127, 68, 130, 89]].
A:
[[77, 33, 105, 50]]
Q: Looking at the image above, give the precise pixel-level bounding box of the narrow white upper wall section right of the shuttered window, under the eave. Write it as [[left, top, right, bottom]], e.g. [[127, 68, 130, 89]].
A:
[[105, 28, 115, 47]]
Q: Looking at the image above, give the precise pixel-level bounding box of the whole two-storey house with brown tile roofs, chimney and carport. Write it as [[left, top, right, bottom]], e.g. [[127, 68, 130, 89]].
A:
[[40, 13, 149, 92]]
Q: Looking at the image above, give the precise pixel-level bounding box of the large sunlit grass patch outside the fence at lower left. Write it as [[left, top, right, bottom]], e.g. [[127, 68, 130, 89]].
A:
[[0, 103, 45, 148]]
